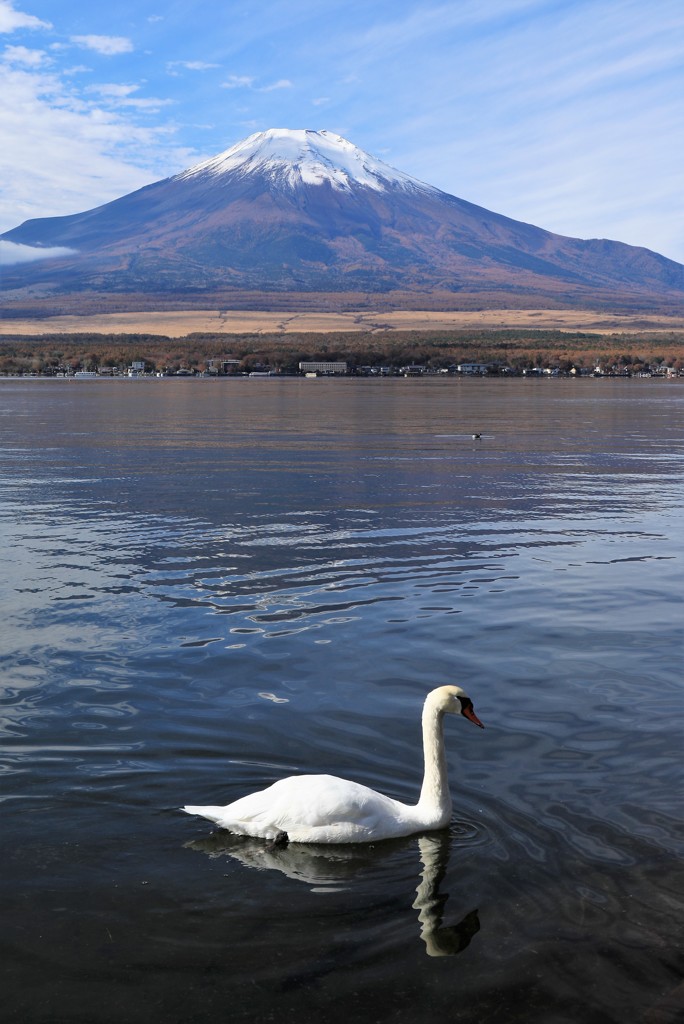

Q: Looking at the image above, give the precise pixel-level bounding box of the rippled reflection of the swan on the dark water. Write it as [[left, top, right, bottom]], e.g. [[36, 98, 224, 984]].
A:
[[184, 829, 480, 956]]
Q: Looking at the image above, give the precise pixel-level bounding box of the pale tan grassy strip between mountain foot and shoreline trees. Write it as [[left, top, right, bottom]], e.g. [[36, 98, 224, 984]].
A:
[[0, 309, 684, 338]]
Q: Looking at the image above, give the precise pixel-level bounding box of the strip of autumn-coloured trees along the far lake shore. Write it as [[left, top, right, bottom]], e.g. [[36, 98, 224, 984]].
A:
[[0, 330, 684, 376]]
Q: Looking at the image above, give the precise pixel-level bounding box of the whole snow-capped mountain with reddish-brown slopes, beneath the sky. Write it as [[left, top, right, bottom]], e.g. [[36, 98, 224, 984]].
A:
[[0, 129, 684, 303]]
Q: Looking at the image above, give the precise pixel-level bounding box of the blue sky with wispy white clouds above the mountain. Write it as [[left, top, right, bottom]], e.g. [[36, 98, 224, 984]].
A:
[[0, 0, 684, 262]]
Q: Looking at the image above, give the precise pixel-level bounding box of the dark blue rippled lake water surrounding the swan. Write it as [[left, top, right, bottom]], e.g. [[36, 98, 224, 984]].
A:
[[0, 379, 684, 1024]]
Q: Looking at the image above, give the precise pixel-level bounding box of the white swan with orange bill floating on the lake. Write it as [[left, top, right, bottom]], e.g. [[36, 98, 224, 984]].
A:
[[183, 686, 484, 843]]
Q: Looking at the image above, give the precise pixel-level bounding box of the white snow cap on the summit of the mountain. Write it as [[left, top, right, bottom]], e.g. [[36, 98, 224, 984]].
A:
[[177, 128, 434, 191]]
